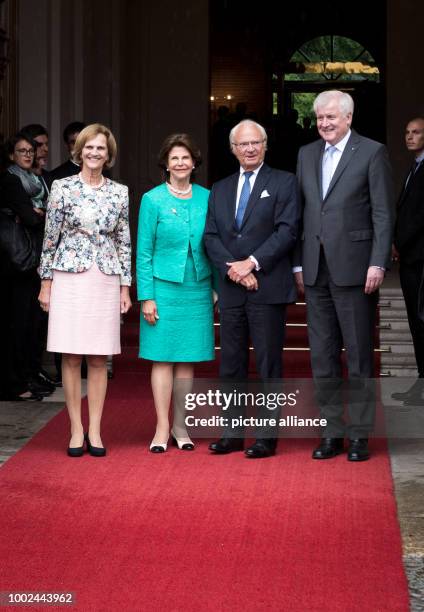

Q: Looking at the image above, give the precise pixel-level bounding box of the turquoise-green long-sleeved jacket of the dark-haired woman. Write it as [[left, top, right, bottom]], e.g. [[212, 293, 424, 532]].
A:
[[136, 183, 212, 300]]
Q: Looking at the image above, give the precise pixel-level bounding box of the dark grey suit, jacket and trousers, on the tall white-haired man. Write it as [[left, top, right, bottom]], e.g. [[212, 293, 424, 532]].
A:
[[294, 130, 394, 437]]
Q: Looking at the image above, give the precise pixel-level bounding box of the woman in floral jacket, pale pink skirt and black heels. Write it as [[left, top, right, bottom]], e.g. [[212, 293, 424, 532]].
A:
[[39, 124, 131, 457]]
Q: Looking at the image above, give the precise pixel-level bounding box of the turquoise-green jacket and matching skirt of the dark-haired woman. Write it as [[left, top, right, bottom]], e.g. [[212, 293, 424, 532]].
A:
[[137, 183, 215, 362]]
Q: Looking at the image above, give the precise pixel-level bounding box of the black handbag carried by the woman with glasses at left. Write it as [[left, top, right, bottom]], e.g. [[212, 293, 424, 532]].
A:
[[0, 208, 39, 272]]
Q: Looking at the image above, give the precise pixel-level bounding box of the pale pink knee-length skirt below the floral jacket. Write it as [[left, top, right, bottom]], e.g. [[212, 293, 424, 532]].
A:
[[47, 263, 121, 355]]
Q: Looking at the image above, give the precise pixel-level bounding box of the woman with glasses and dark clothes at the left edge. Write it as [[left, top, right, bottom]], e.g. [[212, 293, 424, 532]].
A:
[[0, 132, 46, 401]]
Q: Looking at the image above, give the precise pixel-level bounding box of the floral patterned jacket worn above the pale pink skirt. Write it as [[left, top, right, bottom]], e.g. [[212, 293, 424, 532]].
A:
[[39, 175, 131, 285]]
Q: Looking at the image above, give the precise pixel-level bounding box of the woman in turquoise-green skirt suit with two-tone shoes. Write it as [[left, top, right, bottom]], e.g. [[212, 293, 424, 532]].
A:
[[137, 134, 214, 453]]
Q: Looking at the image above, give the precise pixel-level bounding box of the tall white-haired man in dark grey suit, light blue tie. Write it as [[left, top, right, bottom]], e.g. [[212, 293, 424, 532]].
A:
[[294, 90, 393, 461]]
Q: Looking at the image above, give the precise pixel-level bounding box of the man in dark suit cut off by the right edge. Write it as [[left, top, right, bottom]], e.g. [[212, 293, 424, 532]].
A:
[[392, 117, 424, 406]]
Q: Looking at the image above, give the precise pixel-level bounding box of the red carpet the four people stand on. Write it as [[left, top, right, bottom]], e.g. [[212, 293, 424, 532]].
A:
[[0, 372, 409, 612]]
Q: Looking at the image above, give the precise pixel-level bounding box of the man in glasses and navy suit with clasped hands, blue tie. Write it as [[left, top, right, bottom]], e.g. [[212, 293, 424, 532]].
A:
[[204, 120, 299, 458]]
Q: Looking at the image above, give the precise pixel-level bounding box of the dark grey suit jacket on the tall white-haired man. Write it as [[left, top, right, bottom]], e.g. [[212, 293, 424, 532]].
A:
[[297, 130, 394, 287]]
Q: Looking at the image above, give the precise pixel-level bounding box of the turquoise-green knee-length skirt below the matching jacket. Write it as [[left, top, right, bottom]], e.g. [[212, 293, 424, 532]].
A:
[[139, 254, 215, 363]]
